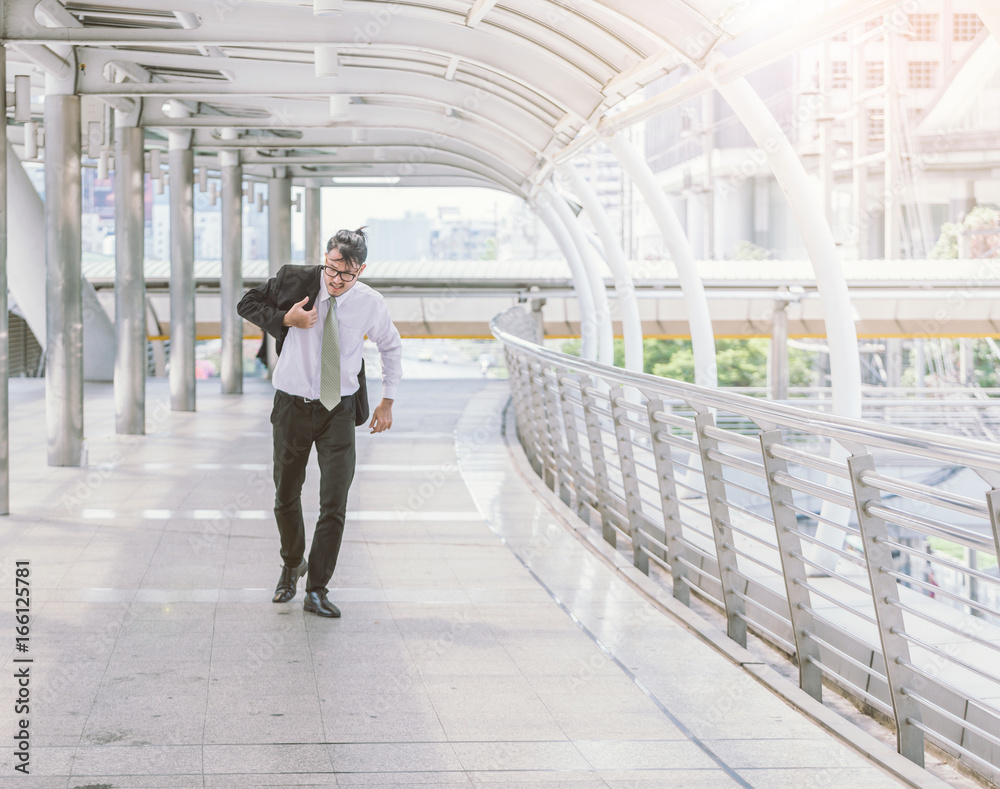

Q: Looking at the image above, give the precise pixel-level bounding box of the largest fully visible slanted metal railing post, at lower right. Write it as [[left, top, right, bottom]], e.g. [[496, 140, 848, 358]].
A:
[[847, 455, 924, 767]]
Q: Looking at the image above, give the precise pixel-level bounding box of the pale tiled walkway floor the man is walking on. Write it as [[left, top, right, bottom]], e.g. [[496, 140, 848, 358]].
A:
[[0, 378, 968, 789]]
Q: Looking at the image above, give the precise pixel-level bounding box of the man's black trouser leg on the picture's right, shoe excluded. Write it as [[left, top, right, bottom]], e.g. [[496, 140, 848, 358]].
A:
[[306, 397, 355, 594]]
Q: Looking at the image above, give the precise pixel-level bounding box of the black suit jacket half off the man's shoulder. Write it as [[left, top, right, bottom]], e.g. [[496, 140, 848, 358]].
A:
[[236, 265, 369, 427]]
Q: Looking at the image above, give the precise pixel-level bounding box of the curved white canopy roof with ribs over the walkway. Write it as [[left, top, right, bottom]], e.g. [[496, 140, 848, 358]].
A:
[[3, 0, 745, 191]]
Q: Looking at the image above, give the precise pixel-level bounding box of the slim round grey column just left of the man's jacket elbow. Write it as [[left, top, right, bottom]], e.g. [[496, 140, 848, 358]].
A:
[[219, 151, 243, 394]]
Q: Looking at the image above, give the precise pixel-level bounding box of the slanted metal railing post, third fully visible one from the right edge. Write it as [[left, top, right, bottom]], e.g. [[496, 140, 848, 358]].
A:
[[694, 413, 747, 647]]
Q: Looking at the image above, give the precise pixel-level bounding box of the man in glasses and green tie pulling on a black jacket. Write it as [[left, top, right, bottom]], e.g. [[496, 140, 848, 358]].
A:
[[237, 229, 402, 617]]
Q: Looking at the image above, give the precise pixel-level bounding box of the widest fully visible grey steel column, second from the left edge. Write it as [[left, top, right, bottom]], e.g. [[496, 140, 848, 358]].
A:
[[45, 94, 86, 466]]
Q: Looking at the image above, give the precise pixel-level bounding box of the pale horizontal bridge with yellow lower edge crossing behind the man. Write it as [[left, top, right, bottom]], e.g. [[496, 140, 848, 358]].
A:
[[84, 259, 1000, 338]]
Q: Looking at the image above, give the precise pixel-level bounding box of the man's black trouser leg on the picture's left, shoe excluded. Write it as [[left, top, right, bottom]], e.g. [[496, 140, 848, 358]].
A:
[[271, 391, 312, 567]]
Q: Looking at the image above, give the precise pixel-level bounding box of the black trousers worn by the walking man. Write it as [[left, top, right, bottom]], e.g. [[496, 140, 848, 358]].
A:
[[271, 389, 355, 592]]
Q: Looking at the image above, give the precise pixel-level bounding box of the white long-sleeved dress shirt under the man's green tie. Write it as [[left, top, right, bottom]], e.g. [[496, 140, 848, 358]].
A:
[[272, 282, 403, 400]]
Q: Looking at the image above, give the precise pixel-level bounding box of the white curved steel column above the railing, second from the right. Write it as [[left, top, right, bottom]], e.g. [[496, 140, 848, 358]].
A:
[[604, 133, 719, 386]]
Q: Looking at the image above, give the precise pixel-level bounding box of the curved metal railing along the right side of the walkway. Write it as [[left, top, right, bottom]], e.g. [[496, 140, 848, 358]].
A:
[[492, 308, 1000, 782]]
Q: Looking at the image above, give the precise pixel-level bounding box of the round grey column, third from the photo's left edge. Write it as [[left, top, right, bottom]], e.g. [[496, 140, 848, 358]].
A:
[[114, 126, 146, 435]]
